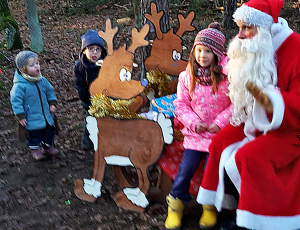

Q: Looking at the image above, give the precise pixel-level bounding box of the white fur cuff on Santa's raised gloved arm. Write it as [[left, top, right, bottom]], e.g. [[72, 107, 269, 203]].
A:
[[253, 88, 285, 134]]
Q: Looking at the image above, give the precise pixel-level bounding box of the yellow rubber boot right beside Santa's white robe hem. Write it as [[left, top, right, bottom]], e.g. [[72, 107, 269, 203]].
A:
[[199, 204, 218, 229]]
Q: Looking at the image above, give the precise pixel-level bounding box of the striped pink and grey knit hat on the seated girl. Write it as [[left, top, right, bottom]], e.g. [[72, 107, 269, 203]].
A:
[[193, 28, 225, 61]]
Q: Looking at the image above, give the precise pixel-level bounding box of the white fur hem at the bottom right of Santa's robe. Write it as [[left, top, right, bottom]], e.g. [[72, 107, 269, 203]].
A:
[[236, 209, 300, 230]]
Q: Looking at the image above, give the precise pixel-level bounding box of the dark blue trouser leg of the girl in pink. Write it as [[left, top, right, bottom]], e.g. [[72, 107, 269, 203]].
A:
[[170, 149, 207, 204]]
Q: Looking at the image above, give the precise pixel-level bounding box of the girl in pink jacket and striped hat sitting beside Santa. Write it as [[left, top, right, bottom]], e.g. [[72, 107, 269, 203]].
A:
[[165, 23, 232, 229]]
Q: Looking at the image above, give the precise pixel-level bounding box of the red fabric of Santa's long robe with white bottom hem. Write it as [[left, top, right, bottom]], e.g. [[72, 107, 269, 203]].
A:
[[201, 33, 300, 230]]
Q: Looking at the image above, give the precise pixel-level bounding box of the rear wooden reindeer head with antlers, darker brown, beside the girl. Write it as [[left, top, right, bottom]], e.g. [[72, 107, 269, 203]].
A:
[[145, 2, 195, 76]]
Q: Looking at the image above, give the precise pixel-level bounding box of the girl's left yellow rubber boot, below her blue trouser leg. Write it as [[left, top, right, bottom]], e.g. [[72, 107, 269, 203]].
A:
[[165, 195, 184, 230]]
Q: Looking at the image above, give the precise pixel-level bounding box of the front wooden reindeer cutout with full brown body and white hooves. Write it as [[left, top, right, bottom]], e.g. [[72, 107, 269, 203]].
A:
[[74, 19, 173, 212]]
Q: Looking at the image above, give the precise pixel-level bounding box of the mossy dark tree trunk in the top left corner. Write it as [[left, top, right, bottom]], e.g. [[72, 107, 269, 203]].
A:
[[0, 0, 23, 50]]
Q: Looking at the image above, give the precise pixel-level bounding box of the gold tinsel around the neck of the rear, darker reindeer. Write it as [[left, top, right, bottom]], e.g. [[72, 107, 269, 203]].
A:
[[143, 70, 171, 97]]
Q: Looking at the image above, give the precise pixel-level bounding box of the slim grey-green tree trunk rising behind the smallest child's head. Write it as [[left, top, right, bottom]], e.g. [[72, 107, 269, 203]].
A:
[[25, 0, 44, 53]]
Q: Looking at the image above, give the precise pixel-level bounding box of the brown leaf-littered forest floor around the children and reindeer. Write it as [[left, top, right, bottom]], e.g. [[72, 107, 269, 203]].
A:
[[0, 0, 300, 230]]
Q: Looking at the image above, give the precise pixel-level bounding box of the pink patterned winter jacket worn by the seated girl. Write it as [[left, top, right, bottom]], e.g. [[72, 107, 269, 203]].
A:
[[174, 59, 232, 152]]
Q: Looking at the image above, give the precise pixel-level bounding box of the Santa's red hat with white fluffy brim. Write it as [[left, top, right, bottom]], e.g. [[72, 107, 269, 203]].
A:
[[233, 0, 284, 31]]
